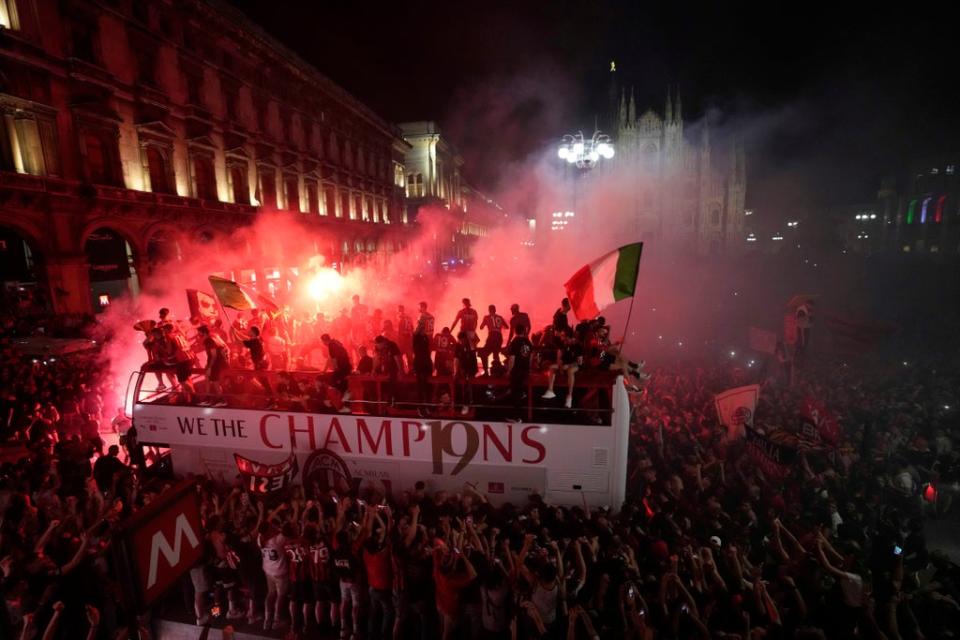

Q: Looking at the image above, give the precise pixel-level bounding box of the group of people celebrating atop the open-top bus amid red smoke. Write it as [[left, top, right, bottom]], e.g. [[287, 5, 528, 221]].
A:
[[137, 296, 645, 420]]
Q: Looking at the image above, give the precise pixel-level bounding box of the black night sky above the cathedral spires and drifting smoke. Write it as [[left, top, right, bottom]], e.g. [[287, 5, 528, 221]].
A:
[[232, 0, 960, 218]]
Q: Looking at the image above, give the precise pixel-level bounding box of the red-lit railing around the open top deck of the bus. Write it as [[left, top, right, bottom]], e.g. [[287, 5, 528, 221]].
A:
[[128, 369, 621, 425]]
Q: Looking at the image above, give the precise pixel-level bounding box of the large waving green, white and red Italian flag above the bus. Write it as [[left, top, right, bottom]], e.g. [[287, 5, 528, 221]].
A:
[[563, 242, 643, 320]]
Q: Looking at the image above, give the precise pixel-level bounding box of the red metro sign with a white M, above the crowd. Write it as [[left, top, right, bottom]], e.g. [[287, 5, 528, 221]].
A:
[[127, 481, 204, 607]]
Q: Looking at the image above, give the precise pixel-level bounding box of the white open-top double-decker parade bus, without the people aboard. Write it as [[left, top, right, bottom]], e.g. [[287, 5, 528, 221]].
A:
[[127, 371, 630, 509]]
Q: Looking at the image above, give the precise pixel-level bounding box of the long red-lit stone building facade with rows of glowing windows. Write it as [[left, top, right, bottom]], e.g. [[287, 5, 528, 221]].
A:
[[0, 0, 409, 313]]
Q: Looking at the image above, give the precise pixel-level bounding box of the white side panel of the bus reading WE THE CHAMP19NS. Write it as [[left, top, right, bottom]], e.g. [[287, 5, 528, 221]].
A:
[[133, 396, 629, 506]]
